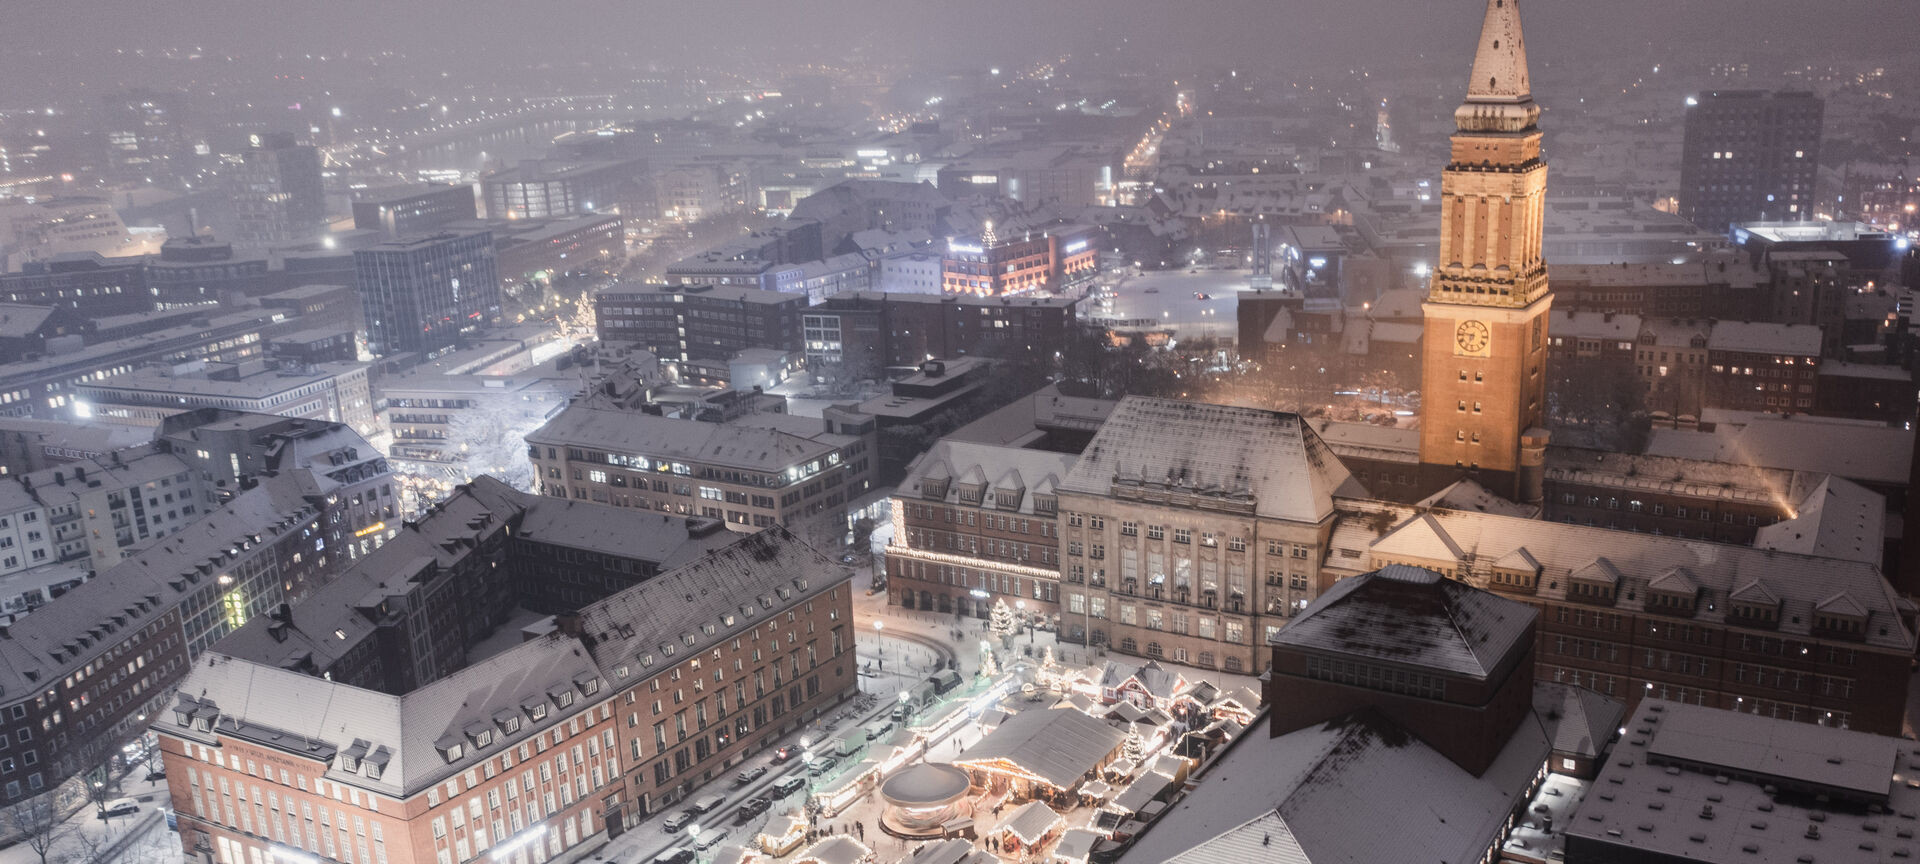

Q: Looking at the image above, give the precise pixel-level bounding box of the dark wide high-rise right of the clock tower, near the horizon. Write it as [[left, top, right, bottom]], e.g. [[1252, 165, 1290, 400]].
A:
[[1680, 90, 1824, 232]]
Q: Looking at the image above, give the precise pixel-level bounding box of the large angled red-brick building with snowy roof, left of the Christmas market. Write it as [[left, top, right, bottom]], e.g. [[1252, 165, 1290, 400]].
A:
[[154, 528, 856, 864]]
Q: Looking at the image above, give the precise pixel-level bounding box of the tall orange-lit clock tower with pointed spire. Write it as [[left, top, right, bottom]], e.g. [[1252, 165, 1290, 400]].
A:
[[1421, 0, 1553, 503]]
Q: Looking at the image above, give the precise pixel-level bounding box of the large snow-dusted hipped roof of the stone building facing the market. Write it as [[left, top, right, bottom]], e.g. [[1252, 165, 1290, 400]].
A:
[[1062, 396, 1361, 522]]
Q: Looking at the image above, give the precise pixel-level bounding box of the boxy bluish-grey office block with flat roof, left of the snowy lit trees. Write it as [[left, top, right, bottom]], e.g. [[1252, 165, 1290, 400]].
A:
[[353, 230, 499, 355]]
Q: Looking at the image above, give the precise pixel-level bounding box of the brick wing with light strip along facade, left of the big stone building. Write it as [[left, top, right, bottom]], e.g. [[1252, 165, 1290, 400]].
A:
[[887, 440, 1087, 626]]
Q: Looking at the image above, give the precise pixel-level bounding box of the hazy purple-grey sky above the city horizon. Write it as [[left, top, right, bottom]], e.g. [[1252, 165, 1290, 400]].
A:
[[0, 0, 1920, 85]]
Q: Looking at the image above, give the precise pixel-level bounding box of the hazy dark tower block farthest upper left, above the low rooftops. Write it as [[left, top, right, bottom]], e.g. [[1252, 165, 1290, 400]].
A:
[[228, 132, 326, 246]]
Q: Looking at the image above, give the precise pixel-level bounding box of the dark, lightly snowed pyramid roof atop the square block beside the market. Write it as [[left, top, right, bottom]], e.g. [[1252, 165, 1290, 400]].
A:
[[1273, 564, 1536, 678]]
